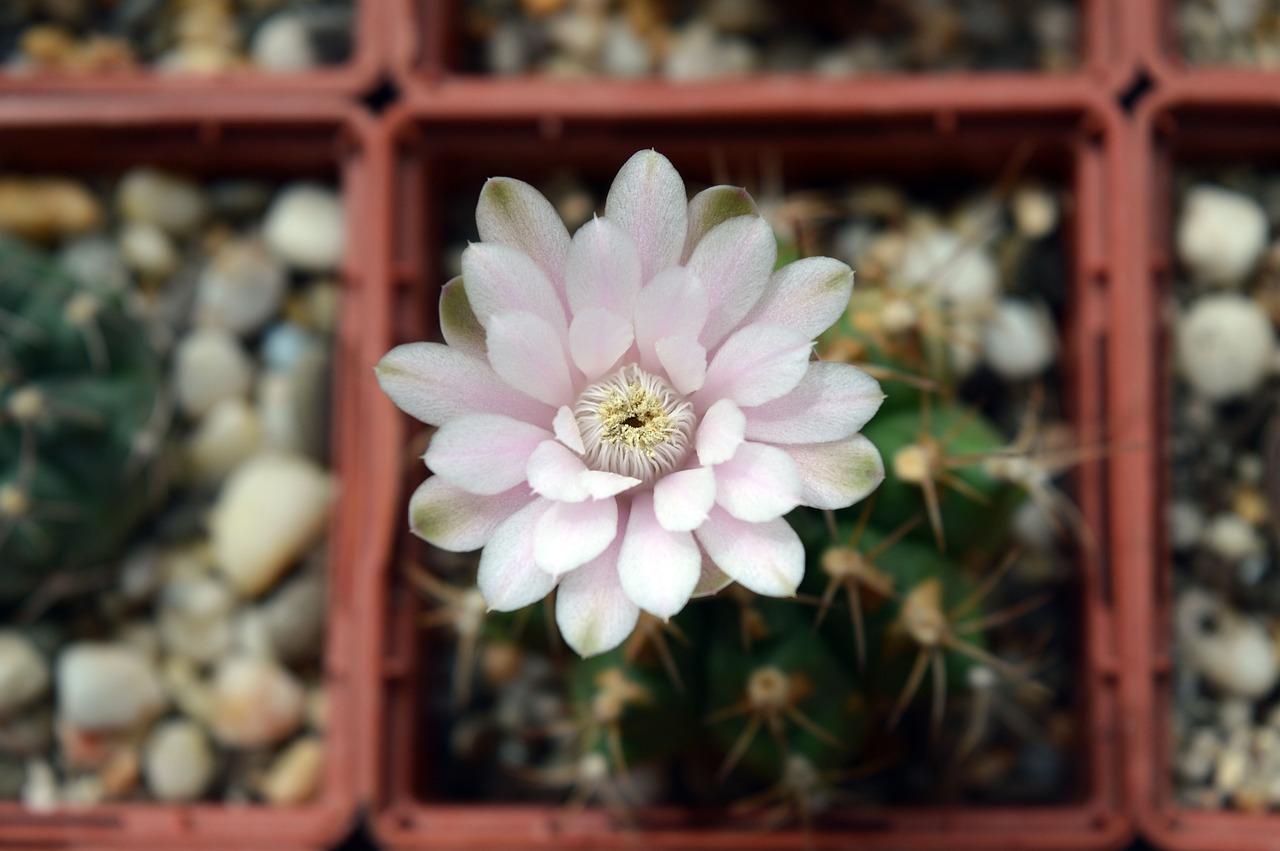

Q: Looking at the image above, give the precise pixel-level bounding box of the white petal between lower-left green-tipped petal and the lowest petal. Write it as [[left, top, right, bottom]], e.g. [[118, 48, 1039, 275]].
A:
[[476, 499, 556, 612]]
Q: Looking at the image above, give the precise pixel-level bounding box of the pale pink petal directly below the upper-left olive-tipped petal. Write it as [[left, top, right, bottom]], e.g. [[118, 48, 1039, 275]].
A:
[[462, 242, 568, 339]]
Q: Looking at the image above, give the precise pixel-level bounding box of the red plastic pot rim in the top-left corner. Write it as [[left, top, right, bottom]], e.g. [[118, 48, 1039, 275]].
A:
[[0, 0, 390, 96]]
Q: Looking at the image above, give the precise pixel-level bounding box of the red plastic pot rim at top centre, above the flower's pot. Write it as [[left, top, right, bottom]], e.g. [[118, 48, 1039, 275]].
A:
[[388, 0, 1137, 95]]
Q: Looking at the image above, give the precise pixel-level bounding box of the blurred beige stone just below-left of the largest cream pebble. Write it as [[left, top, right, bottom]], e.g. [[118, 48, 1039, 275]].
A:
[[157, 576, 236, 664]]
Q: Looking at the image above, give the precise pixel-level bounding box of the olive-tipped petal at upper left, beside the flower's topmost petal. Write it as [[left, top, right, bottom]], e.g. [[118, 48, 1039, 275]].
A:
[[476, 178, 570, 285]]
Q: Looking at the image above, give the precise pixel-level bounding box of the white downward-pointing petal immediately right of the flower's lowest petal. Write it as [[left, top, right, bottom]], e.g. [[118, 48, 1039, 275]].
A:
[[618, 494, 703, 618]]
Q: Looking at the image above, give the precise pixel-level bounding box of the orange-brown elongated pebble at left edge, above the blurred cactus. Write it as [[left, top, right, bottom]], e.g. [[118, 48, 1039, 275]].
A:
[[0, 177, 102, 242]]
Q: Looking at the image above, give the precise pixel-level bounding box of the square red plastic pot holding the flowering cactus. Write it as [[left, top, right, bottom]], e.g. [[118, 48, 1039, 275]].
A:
[[366, 89, 1132, 848]]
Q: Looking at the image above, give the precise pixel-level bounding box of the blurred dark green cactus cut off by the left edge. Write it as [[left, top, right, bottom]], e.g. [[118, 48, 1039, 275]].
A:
[[0, 238, 168, 600]]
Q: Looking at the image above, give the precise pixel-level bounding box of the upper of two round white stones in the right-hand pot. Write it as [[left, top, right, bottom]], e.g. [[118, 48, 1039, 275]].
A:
[[1178, 184, 1267, 285]]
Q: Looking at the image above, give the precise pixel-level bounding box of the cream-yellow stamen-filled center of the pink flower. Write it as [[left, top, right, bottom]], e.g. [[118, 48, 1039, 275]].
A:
[[573, 365, 694, 484]]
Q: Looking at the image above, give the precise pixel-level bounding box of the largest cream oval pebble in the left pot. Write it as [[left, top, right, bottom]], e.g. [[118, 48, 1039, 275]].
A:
[[211, 454, 333, 596]]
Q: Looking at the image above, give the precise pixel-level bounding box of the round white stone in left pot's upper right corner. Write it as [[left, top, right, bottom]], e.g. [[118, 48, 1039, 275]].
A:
[[262, 183, 347, 273]]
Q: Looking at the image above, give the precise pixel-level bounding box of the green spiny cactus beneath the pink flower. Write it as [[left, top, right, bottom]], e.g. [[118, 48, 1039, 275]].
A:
[[412, 168, 1084, 825]]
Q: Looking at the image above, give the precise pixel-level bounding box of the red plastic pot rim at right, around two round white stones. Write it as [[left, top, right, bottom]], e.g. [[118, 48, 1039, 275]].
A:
[[1131, 87, 1280, 851]]
